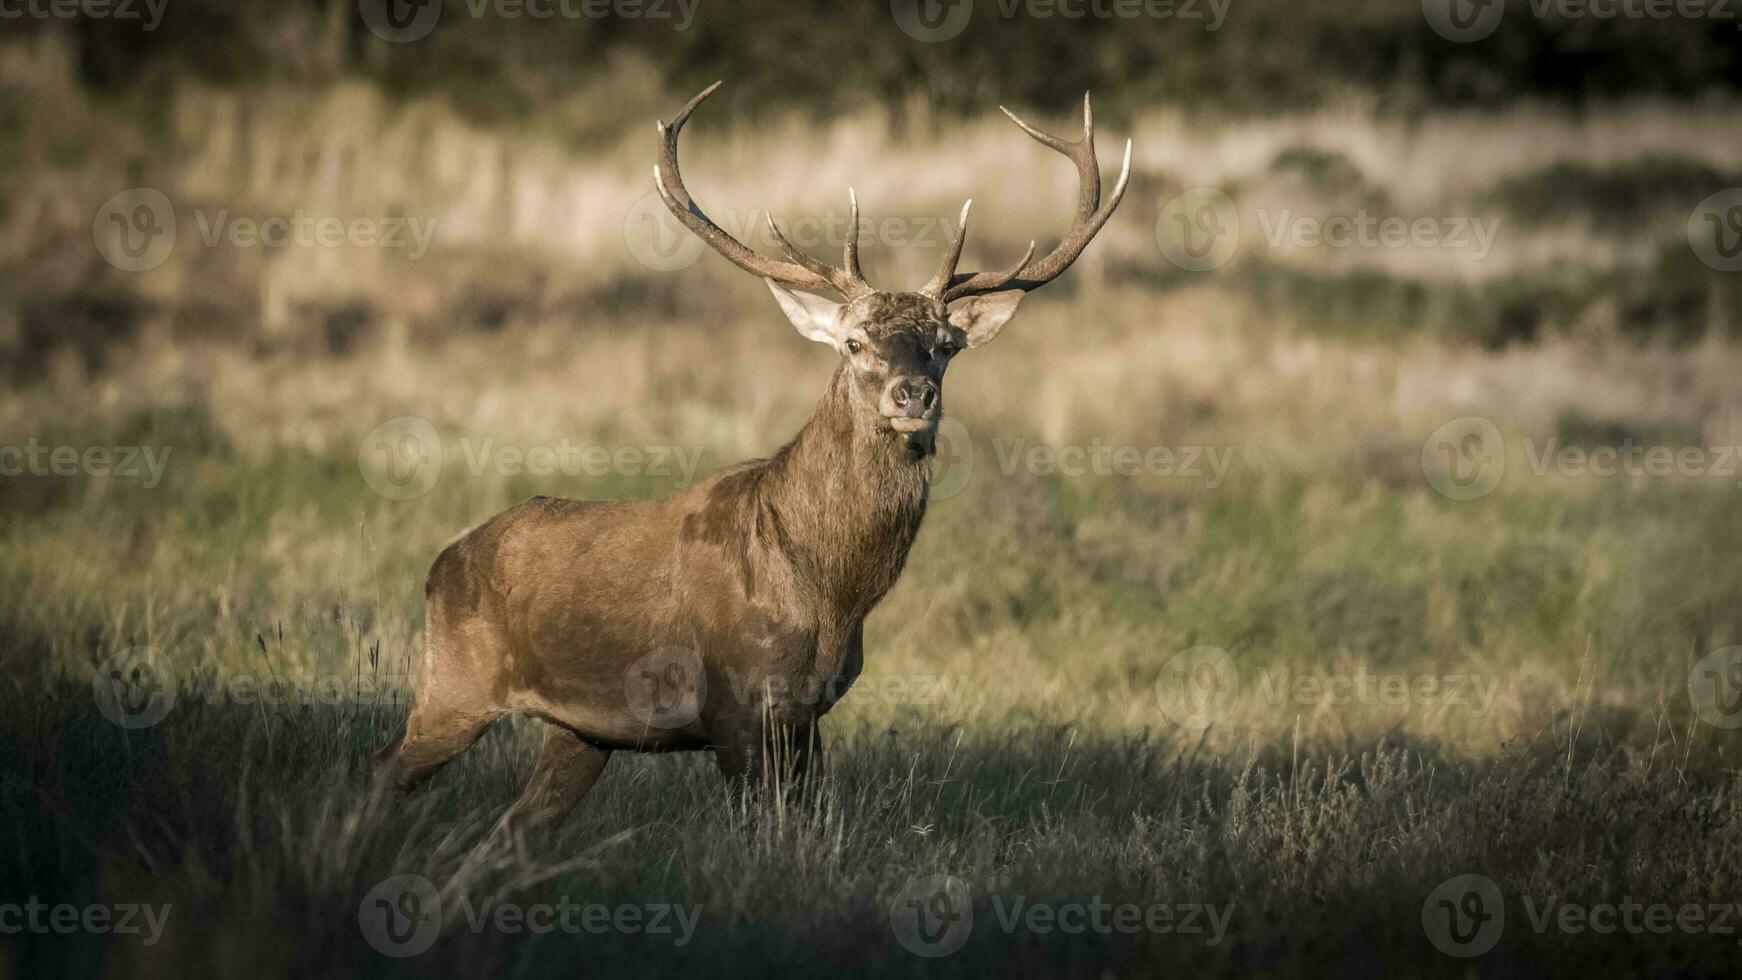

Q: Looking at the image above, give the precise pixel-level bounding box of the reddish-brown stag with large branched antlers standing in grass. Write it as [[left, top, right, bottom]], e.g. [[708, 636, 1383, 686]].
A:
[[381, 82, 1131, 822]]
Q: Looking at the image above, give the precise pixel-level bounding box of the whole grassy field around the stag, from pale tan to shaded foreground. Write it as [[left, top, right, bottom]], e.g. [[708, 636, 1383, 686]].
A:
[[0, 46, 1742, 977]]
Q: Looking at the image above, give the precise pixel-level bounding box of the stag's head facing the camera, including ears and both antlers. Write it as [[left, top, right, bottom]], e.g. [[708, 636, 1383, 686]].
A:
[[653, 82, 1131, 446]]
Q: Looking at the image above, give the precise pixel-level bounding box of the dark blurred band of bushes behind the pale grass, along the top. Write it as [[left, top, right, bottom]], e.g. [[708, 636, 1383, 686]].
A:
[[37, 0, 1742, 120]]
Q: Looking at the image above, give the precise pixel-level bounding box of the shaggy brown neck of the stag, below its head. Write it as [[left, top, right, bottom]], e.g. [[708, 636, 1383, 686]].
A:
[[765, 366, 930, 621]]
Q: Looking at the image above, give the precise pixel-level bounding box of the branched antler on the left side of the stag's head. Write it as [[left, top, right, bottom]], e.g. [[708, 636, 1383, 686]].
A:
[[653, 82, 874, 301]]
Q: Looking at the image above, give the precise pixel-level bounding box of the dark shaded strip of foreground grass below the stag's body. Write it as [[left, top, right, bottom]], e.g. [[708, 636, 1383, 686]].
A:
[[0, 688, 1742, 977]]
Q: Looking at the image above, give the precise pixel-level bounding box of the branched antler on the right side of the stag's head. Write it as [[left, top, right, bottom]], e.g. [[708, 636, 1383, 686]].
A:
[[922, 92, 1131, 303]]
